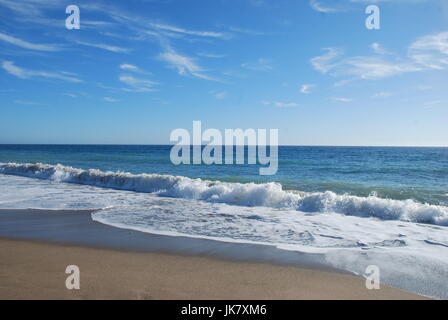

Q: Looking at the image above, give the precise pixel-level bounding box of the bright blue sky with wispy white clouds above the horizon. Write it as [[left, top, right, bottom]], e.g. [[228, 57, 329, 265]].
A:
[[0, 0, 448, 146]]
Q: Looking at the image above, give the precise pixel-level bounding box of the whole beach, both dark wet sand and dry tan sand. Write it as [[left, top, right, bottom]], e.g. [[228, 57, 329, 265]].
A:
[[0, 209, 426, 299]]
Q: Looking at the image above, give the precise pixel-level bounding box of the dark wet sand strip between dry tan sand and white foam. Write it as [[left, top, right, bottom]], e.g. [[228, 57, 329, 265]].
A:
[[0, 209, 332, 274]]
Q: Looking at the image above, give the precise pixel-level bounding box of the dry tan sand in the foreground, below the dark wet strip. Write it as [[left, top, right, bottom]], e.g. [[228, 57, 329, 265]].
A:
[[0, 239, 428, 299]]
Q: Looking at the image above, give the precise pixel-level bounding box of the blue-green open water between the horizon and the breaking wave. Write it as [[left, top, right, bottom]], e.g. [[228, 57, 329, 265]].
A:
[[0, 145, 448, 205]]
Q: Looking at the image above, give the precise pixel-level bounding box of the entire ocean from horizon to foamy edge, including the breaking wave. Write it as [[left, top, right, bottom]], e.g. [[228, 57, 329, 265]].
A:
[[0, 145, 448, 298]]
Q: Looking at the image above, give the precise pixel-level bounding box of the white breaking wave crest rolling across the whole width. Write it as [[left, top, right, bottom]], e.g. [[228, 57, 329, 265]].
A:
[[0, 163, 448, 226]]
